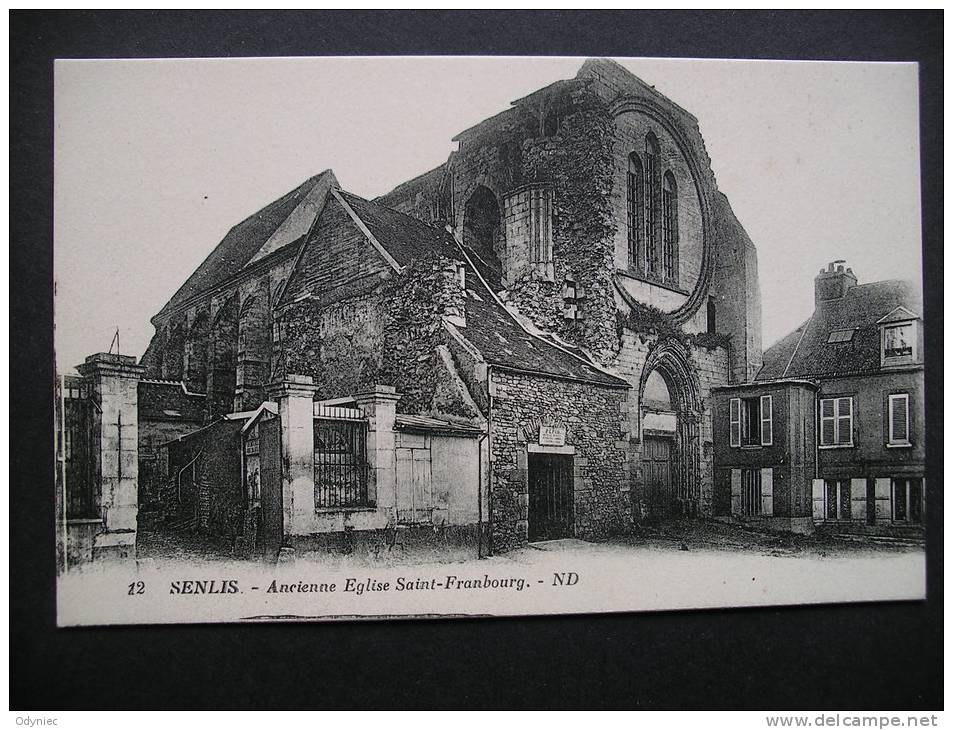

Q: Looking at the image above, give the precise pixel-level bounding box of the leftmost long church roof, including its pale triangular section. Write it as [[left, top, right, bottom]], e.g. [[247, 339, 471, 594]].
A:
[[158, 170, 337, 317]]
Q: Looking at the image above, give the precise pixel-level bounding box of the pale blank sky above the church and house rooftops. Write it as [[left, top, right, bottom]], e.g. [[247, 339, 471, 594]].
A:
[[54, 57, 921, 370]]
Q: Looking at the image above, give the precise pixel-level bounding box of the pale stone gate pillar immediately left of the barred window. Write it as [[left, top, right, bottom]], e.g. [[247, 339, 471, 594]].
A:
[[268, 375, 317, 535]]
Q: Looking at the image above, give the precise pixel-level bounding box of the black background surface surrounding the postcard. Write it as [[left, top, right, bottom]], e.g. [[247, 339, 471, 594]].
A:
[[10, 11, 943, 710]]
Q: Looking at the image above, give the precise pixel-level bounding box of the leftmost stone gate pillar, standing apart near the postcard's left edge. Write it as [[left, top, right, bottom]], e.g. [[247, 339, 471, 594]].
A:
[[77, 352, 145, 560]]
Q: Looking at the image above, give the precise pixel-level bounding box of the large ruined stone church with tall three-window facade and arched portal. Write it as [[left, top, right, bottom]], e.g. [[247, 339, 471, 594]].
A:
[[140, 59, 761, 552]]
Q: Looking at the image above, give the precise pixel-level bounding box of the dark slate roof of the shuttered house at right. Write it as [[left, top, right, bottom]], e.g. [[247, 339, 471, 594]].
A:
[[756, 279, 922, 380]]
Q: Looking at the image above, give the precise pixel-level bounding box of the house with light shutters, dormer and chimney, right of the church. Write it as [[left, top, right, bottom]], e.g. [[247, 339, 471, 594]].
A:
[[715, 261, 926, 534]]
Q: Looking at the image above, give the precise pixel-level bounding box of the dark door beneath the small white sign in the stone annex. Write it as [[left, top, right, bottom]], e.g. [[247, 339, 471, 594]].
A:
[[529, 454, 575, 542]]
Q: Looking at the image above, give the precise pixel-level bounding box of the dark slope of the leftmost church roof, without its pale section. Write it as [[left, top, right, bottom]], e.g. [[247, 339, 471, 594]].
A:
[[159, 170, 333, 316]]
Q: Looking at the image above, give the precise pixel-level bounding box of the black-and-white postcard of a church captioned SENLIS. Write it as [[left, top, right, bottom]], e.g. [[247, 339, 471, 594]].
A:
[[54, 57, 924, 626]]
